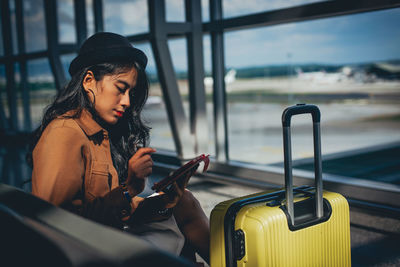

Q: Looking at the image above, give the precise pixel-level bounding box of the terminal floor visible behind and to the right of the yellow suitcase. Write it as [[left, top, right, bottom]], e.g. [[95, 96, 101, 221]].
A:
[[188, 177, 400, 266]]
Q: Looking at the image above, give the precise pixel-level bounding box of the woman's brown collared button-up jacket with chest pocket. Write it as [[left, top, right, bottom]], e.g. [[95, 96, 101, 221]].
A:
[[32, 110, 131, 227]]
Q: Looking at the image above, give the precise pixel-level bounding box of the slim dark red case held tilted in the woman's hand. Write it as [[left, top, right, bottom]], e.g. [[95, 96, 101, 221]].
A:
[[151, 154, 210, 192]]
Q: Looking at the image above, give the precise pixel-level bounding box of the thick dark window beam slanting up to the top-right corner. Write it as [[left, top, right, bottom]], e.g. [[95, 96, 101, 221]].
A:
[[204, 0, 400, 31]]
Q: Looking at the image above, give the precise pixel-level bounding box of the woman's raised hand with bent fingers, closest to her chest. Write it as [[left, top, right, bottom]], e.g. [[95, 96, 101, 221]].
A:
[[126, 147, 156, 196]]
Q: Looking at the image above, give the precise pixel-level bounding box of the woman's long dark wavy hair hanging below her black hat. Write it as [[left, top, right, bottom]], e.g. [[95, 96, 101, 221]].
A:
[[27, 62, 150, 182]]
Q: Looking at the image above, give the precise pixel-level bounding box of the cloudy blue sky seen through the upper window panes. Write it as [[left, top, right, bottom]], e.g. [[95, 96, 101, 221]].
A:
[[0, 0, 400, 77]]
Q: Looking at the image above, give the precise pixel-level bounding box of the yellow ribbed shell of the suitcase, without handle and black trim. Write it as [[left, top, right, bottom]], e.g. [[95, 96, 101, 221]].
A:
[[210, 191, 351, 267]]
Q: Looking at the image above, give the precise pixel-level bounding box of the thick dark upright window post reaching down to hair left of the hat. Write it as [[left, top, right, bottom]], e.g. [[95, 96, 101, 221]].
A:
[[44, 0, 67, 90]]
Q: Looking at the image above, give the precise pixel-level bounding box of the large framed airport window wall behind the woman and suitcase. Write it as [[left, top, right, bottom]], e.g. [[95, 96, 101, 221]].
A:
[[0, 0, 400, 208]]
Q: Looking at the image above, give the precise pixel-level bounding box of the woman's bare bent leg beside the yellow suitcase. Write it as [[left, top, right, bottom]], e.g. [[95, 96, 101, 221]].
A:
[[174, 189, 210, 262]]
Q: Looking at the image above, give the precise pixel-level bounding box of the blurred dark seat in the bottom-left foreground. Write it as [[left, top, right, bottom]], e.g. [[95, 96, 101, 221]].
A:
[[0, 184, 193, 267]]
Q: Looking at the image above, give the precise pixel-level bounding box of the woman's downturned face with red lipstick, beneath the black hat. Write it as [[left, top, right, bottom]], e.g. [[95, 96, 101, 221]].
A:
[[83, 67, 138, 124]]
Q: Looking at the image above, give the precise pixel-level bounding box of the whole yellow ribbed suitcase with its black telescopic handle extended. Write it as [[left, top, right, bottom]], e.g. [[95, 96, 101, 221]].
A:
[[210, 105, 351, 267]]
